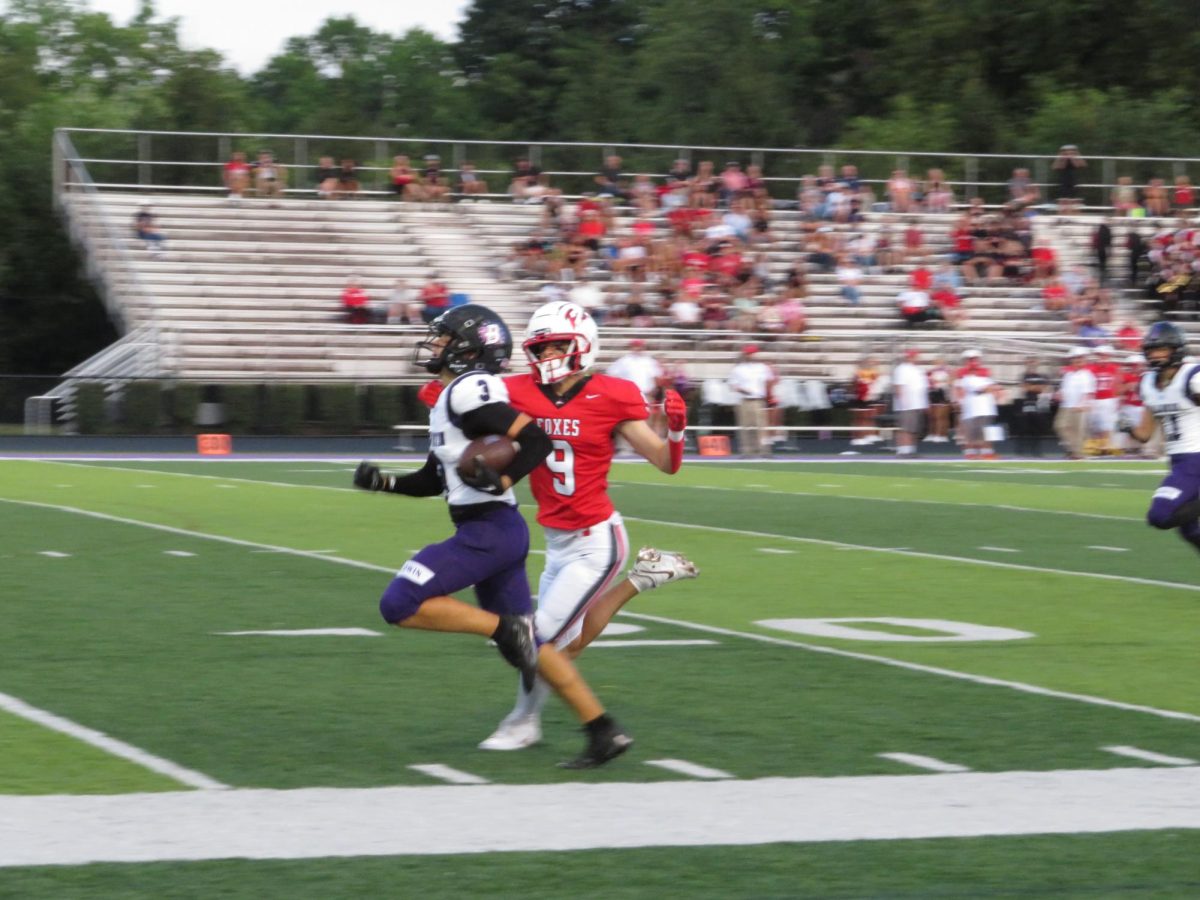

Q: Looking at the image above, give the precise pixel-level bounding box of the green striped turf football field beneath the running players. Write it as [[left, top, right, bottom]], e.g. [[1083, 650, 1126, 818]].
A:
[[0, 460, 1200, 898]]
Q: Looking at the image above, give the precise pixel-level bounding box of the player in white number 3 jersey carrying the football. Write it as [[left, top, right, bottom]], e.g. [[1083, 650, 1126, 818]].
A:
[[354, 304, 632, 768]]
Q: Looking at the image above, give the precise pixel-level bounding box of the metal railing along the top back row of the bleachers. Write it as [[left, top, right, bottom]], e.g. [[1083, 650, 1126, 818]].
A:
[[59, 128, 1200, 209]]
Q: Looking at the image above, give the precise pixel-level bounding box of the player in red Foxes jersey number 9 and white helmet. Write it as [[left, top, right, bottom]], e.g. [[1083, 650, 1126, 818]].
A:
[[480, 301, 698, 750]]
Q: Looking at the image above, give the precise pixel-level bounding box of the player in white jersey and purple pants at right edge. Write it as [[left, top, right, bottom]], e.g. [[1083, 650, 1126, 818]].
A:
[[1121, 322, 1200, 550]]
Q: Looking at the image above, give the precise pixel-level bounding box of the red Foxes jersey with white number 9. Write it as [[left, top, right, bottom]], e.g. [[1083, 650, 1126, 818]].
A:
[[504, 374, 649, 532]]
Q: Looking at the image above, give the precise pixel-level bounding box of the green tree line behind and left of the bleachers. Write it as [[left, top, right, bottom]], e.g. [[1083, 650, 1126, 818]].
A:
[[0, 0, 1200, 373]]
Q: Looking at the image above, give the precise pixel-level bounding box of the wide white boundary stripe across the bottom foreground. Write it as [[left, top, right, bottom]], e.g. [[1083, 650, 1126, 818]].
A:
[[0, 767, 1200, 866]]
